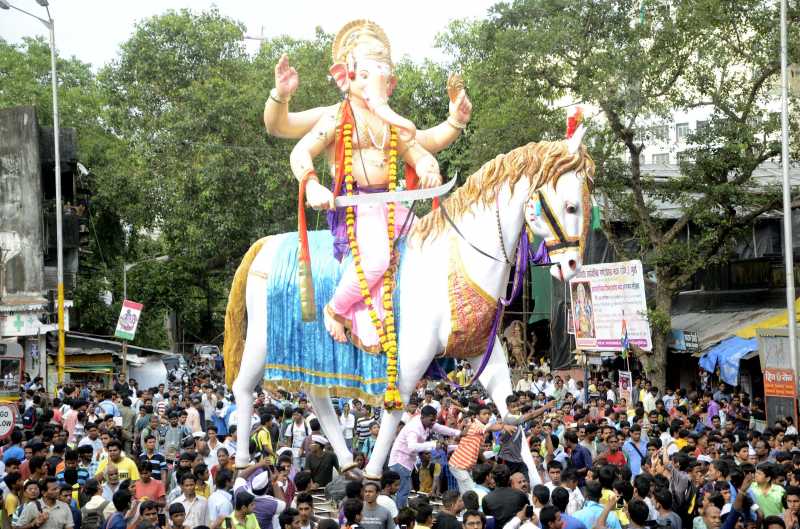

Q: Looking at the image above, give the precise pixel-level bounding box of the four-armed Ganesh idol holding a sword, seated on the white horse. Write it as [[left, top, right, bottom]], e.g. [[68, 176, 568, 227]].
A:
[[264, 20, 472, 350]]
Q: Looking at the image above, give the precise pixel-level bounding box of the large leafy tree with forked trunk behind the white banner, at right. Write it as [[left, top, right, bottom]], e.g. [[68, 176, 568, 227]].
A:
[[443, 0, 798, 385]]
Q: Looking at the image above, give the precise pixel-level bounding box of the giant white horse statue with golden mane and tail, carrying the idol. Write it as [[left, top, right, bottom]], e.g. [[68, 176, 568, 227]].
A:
[[224, 125, 594, 479]]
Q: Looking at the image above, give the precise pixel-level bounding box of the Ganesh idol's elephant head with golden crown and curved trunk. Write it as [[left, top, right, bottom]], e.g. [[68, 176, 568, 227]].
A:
[[330, 20, 416, 139]]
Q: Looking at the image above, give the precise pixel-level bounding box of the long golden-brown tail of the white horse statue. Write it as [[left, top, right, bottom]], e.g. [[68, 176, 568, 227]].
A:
[[222, 237, 269, 387]]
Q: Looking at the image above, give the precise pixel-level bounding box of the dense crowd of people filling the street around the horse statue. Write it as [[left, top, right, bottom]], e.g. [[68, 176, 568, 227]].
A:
[[0, 356, 800, 529]]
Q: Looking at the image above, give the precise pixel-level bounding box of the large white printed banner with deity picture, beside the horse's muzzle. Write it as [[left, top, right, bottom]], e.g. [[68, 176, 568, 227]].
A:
[[570, 260, 653, 351]]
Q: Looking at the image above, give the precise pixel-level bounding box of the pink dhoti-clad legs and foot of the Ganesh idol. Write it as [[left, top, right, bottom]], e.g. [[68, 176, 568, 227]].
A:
[[329, 204, 415, 352]]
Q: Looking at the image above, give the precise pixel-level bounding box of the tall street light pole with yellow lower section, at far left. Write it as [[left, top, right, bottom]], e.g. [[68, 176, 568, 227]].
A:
[[0, 0, 65, 385]]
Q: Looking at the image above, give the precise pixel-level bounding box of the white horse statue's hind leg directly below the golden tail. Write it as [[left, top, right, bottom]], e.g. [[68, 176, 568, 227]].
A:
[[232, 275, 267, 468]]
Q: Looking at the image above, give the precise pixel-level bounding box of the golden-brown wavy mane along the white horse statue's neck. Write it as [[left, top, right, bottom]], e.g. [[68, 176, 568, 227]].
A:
[[410, 141, 594, 243]]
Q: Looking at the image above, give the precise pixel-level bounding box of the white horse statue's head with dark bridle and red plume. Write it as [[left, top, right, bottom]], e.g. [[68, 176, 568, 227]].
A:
[[525, 111, 594, 281]]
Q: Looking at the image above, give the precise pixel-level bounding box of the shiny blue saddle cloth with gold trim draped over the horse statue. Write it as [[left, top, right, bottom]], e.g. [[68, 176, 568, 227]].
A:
[[264, 231, 405, 403]]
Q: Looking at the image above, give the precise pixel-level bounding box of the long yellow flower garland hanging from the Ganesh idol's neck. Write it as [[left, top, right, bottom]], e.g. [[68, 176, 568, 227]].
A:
[[342, 123, 403, 410]]
